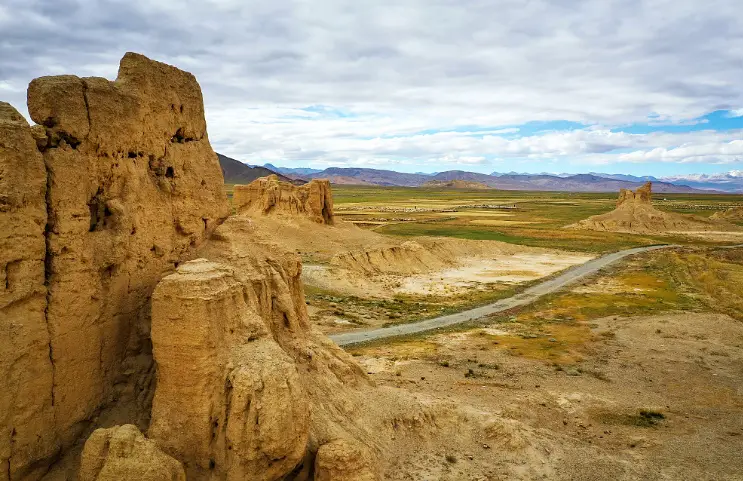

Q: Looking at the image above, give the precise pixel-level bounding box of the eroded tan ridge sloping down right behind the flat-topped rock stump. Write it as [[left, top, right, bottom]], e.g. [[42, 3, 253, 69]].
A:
[[195, 215, 390, 480]]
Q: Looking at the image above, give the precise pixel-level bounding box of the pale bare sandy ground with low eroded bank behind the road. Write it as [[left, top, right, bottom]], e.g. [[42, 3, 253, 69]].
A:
[[248, 213, 592, 298]]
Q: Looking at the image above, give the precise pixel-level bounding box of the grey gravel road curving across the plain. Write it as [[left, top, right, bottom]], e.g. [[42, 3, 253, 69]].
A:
[[329, 245, 674, 346]]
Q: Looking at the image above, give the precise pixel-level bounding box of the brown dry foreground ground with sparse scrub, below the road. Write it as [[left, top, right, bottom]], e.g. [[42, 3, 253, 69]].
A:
[[351, 313, 744, 481]]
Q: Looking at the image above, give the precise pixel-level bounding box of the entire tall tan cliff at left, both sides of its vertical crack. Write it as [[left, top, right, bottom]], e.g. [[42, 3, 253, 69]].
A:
[[0, 53, 229, 480]]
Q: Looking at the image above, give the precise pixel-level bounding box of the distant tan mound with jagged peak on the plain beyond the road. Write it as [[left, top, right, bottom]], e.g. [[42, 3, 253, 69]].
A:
[[567, 182, 732, 234]]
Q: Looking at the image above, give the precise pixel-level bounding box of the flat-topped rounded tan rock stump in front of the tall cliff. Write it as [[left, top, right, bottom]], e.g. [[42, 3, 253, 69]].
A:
[[149, 259, 310, 481]]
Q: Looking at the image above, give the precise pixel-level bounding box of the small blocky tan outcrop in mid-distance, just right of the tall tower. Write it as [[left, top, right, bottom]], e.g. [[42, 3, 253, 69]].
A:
[[233, 175, 333, 224]]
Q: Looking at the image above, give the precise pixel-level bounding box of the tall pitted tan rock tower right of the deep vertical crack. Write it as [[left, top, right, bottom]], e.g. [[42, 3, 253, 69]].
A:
[[28, 54, 227, 448]]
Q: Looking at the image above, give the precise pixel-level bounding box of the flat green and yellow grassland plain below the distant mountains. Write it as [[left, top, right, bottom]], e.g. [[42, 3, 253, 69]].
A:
[[333, 185, 741, 253]]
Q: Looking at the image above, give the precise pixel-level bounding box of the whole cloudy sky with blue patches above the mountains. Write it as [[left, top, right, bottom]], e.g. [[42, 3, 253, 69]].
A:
[[0, 0, 744, 176]]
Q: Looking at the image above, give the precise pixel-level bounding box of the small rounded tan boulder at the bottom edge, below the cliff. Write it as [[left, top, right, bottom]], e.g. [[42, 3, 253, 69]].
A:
[[79, 425, 186, 482]]
